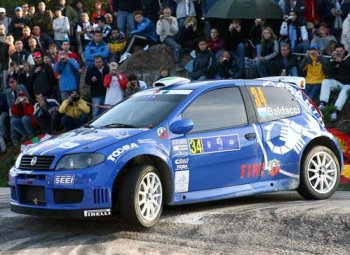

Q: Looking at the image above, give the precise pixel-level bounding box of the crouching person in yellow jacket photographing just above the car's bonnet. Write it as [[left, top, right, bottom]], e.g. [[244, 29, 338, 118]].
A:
[[58, 91, 90, 131]]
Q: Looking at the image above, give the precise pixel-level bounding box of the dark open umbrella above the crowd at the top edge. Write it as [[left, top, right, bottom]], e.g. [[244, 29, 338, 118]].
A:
[[205, 0, 283, 19]]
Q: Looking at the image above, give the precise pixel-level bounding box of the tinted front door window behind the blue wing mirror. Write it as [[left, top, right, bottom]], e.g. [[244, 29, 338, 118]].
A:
[[182, 87, 247, 132]]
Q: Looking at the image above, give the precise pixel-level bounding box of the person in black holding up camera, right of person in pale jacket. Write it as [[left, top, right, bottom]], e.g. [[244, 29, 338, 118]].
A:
[[176, 17, 201, 51]]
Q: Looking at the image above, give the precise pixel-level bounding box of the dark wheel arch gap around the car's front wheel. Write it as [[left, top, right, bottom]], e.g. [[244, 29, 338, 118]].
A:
[[112, 154, 173, 208]]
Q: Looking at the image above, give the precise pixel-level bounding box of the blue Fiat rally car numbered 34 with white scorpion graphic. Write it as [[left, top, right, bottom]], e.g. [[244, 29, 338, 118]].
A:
[[9, 80, 343, 227]]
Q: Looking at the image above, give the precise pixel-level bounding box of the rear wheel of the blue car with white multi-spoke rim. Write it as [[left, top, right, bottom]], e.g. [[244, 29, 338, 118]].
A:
[[297, 146, 340, 199]]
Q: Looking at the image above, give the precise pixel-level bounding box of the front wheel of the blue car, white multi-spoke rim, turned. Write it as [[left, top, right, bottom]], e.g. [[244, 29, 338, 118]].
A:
[[118, 165, 163, 227]]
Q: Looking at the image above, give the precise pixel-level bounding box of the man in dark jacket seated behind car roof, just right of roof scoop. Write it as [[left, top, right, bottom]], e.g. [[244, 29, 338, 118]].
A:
[[190, 39, 216, 81]]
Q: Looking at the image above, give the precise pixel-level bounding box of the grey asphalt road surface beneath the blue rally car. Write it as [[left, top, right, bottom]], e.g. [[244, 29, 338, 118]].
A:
[[0, 188, 350, 255]]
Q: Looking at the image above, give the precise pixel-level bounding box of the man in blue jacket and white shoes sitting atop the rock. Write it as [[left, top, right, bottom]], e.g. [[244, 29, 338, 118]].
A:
[[120, 11, 158, 61]]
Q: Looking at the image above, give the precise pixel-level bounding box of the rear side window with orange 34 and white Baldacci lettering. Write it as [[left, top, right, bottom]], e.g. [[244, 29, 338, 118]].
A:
[[249, 86, 301, 122]]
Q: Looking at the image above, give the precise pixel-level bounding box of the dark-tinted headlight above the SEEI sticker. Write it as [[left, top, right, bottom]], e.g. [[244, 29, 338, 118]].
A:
[[55, 153, 105, 170]]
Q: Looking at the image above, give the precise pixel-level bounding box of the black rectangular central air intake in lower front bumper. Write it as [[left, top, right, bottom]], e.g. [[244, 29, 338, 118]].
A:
[[18, 185, 46, 205]]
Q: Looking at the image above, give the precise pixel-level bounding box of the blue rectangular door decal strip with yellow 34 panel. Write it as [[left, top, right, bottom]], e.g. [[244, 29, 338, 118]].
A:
[[188, 134, 240, 155]]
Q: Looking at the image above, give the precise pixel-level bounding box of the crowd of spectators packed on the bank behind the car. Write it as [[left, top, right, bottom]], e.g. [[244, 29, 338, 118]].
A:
[[0, 0, 350, 151]]
